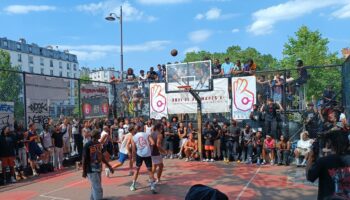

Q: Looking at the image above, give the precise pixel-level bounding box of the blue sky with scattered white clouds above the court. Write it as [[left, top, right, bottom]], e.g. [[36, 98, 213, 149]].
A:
[[0, 0, 350, 71]]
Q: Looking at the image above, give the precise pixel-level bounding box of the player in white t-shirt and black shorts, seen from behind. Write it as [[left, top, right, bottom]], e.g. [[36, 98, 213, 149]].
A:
[[130, 125, 157, 194]]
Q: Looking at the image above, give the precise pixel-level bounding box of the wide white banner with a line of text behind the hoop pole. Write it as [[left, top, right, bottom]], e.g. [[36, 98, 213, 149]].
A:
[[167, 78, 230, 114]]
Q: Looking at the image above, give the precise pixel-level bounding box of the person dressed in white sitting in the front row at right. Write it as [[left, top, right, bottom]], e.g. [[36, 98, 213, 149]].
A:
[[294, 131, 314, 167]]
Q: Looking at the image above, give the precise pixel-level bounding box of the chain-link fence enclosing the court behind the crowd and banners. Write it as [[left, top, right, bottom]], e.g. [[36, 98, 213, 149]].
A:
[[0, 61, 348, 141]]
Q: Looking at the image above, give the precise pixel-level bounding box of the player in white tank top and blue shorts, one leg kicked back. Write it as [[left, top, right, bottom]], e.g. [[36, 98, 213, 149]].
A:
[[113, 123, 137, 176]]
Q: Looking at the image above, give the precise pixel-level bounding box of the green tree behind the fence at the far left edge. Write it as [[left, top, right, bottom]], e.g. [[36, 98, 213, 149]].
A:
[[0, 50, 25, 120]]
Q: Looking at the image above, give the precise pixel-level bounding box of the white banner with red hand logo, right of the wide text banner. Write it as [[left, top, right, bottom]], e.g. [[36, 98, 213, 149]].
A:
[[232, 76, 256, 119]]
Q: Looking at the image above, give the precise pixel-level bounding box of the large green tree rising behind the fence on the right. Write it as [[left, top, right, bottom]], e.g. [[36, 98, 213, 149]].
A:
[[281, 26, 343, 99]]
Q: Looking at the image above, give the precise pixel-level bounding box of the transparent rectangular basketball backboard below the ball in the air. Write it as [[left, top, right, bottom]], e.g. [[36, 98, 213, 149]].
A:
[[165, 60, 213, 93]]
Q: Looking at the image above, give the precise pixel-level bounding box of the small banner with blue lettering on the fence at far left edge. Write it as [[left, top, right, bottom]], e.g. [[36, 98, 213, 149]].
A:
[[0, 102, 15, 130]]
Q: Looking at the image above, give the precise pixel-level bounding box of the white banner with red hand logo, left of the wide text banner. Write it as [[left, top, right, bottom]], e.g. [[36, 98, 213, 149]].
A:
[[149, 83, 168, 119]]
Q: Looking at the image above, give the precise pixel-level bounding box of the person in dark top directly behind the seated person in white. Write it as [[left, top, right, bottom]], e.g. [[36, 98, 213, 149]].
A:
[[303, 102, 319, 138]]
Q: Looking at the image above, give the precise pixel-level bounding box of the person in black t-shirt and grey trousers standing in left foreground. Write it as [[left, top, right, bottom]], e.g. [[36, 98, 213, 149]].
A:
[[82, 130, 114, 200]]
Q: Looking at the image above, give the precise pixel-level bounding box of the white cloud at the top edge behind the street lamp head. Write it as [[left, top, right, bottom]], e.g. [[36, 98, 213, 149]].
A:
[[76, 0, 157, 22]]
